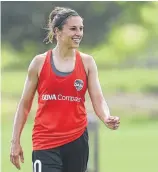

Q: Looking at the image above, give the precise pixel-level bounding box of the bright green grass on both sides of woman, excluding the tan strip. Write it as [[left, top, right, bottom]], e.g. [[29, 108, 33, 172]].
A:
[[1, 70, 158, 172]]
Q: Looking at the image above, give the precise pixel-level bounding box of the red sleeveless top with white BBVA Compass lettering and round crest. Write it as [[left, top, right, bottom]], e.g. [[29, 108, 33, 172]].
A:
[[32, 50, 87, 150]]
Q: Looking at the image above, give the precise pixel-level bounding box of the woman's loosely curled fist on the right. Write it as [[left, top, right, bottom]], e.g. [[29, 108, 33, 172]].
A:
[[104, 116, 120, 130]]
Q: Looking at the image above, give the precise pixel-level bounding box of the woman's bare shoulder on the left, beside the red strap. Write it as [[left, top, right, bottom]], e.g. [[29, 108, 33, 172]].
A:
[[28, 52, 47, 75]]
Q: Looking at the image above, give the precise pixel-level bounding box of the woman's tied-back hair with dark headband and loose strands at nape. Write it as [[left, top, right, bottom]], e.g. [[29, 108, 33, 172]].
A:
[[44, 7, 79, 44]]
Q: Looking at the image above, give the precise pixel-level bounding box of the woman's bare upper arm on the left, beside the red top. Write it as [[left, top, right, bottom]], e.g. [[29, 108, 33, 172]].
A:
[[21, 57, 38, 104]]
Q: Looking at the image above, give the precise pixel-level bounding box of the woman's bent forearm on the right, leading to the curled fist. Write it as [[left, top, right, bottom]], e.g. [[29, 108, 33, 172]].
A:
[[92, 98, 110, 123]]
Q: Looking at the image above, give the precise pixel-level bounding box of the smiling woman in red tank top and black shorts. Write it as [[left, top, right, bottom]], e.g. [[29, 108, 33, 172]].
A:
[[10, 7, 120, 172]]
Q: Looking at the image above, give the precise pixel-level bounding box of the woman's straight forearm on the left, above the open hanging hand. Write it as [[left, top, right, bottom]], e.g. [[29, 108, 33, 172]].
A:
[[12, 102, 31, 143]]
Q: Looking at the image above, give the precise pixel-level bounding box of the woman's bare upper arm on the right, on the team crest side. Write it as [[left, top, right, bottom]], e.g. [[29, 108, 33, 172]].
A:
[[88, 57, 103, 101]]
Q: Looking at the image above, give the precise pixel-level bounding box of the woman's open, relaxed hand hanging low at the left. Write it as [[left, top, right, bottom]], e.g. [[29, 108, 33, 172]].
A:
[[10, 143, 24, 170]]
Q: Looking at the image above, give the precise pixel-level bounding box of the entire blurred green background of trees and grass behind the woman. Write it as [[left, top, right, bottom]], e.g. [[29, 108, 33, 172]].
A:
[[1, 1, 158, 172]]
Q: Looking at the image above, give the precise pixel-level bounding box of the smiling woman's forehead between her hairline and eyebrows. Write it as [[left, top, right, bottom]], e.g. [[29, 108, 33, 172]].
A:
[[65, 16, 83, 26]]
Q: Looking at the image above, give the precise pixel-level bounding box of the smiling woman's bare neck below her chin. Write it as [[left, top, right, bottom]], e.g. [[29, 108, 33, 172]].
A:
[[54, 44, 75, 59]]
